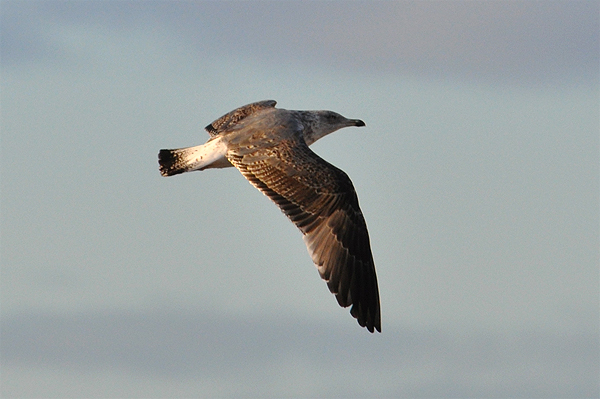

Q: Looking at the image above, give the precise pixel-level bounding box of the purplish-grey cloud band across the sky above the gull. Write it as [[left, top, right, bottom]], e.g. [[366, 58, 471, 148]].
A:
[[2, 1, 600, 82]]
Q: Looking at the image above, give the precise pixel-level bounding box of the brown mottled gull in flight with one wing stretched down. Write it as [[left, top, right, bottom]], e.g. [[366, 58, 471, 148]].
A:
[[158, 100, 381, 332]]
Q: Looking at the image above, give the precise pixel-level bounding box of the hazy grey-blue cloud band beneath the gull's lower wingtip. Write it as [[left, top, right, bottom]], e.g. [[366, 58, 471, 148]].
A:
[[1, 309, 599, 397]]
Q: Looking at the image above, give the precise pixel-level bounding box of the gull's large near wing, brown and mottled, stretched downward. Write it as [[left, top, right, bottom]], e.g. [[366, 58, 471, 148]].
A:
[[227, 134, 381, 332]]
